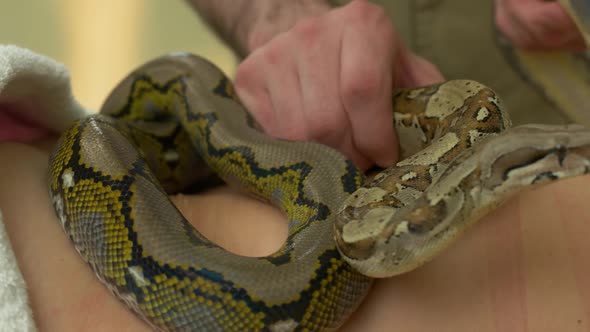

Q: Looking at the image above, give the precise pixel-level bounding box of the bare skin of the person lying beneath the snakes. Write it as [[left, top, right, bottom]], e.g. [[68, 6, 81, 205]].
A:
[[0, 134, 590, 331]]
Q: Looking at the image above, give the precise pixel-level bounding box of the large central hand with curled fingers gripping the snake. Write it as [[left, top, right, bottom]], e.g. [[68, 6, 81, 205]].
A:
[[235, 0, 443, 169]]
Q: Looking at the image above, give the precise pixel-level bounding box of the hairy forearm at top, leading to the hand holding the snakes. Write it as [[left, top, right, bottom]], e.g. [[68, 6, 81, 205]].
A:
[[187, 0, 330, 56]]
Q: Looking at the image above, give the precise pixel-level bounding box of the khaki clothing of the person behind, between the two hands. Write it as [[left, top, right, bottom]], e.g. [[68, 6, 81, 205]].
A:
[[332, 0, 570, 124]]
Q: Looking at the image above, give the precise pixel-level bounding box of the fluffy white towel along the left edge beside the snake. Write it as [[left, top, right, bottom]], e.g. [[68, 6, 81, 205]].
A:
[[0, 45, 87, 332]]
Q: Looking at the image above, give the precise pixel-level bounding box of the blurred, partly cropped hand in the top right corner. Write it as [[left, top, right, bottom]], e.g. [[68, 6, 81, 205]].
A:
[[495, 0, 586, 51]]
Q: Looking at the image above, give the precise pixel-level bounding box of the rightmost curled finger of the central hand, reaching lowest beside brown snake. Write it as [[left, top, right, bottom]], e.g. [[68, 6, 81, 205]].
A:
[[340, 16, 398, 167]]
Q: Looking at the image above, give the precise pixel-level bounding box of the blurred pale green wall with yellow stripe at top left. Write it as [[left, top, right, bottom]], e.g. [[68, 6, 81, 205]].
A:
[[0, 0, 236, 110]]
